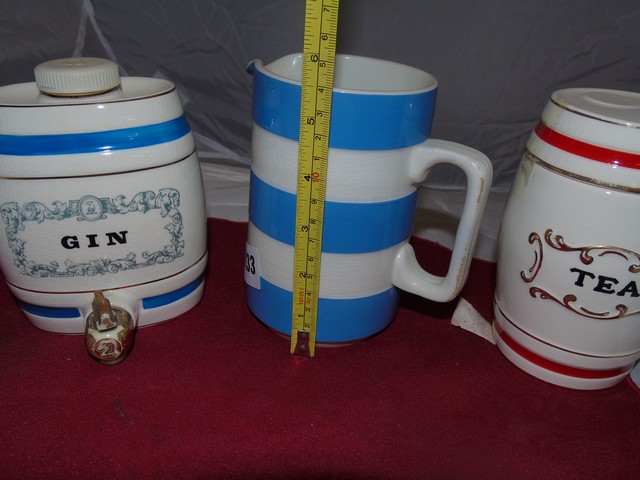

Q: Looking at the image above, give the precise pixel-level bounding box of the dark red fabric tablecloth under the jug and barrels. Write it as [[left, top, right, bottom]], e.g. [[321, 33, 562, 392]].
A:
[[0, 219, 640, 480]]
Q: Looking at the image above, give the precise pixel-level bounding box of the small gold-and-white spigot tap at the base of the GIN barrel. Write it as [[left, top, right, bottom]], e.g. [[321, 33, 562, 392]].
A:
[[84, 290, 135, 365]]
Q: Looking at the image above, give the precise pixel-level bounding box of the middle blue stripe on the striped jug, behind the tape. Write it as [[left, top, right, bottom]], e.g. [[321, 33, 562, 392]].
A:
[[249, 172, 418, 253]]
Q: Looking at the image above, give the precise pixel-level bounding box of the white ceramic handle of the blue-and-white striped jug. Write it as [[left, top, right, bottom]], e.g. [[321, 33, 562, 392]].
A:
[[392, 139, 493, 302]]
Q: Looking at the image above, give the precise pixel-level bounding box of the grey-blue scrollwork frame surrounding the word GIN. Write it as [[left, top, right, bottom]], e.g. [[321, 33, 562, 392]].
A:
[[0, 188, 185, 277]]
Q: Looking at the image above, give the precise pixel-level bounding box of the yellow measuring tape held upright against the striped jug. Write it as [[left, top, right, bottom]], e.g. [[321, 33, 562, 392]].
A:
[[291, 0, 339, 357]]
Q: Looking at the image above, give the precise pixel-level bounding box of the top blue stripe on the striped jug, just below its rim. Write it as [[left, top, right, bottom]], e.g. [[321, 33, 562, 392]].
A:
[[253, 69, 436, 150]]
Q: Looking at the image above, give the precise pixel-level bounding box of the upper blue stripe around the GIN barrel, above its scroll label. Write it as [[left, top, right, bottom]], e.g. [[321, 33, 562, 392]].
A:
[[0, 115, 191, 156]]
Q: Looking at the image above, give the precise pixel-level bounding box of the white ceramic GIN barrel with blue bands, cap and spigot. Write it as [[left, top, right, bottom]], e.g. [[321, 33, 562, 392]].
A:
[[0, 58, 207, 363]]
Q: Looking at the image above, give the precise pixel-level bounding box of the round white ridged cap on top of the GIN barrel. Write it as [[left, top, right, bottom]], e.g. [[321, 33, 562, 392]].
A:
[[34, 57, 120, 97]]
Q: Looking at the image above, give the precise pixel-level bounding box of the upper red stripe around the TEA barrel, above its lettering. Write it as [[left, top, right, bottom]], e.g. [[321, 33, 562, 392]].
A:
[[535, 122, 640, 169]]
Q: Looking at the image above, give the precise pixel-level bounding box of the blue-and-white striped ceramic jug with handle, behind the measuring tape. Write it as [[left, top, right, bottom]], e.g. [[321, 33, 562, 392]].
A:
[[246, 54, 492, 343]]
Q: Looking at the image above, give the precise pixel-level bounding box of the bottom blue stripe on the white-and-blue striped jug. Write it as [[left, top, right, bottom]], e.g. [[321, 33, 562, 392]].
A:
[[247, 278, 399, 342]]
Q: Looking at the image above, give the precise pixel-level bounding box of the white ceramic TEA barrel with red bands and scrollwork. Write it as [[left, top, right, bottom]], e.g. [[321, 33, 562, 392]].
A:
[[494, 88, 640, 389]]
